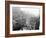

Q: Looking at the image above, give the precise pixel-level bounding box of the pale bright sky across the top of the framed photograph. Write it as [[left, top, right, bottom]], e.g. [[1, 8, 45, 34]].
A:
[[12, 7, 40, 17]]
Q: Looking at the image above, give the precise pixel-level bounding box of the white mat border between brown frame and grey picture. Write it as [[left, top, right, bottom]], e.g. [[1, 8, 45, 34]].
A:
[[10, 4, 43, 34]]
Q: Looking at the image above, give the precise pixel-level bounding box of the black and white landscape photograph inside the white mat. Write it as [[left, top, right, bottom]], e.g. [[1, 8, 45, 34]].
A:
[[12, 7, 40, 31]]
